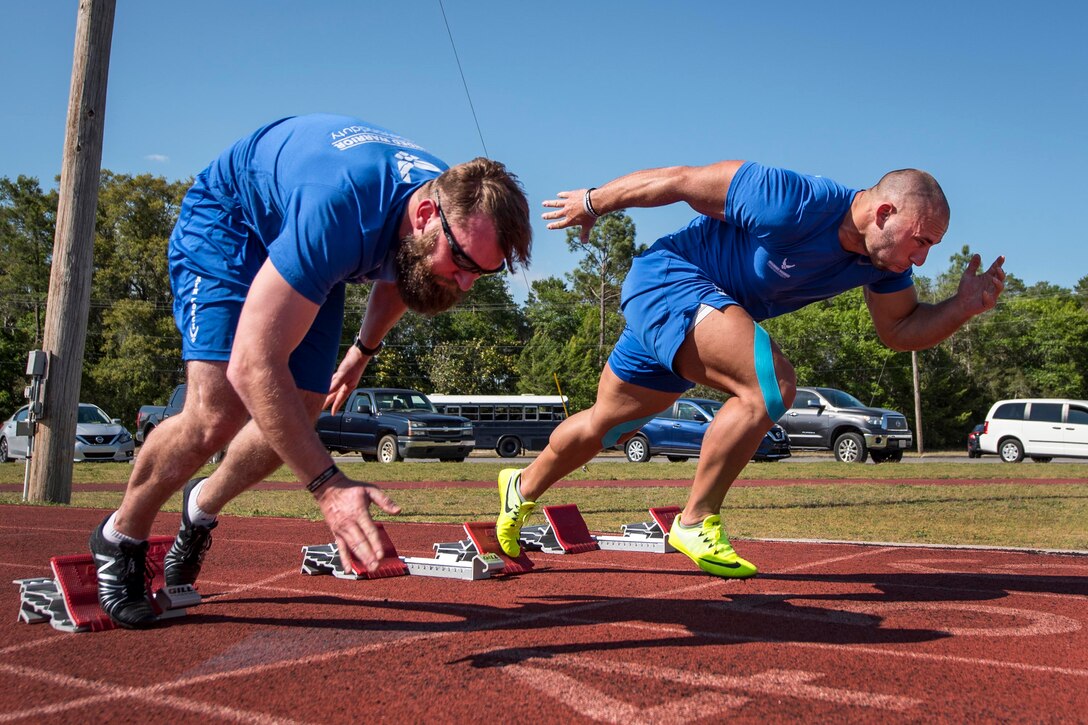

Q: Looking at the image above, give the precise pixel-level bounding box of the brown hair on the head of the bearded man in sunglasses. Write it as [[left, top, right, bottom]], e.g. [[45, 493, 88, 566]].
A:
[[432, 156, 533, 269]]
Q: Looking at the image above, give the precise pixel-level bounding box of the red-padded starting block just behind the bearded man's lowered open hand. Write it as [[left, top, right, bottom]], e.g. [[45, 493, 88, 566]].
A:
[[302, 523, 533, 581]]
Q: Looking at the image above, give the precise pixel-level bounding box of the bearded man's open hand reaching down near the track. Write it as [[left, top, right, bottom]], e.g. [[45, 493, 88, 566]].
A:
[[316, 474, 400, 572]]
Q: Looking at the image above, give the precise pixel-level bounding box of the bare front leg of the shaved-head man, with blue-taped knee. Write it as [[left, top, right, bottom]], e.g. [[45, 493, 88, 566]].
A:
[[675, 306, 796, 525]]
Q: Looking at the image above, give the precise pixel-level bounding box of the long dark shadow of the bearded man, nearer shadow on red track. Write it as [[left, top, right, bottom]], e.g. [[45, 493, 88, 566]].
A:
[[191, 593, 950, 653]]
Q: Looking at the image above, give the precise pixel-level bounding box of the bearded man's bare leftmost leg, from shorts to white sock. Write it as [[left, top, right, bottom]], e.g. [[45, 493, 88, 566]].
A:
[[113, 360, 247, 540]]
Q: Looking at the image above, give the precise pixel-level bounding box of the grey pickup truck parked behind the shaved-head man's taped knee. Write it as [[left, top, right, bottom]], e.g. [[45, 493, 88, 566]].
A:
[[778, 388, 914, 463]]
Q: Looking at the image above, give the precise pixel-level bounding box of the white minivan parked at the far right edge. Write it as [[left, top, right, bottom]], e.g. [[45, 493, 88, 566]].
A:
[[978, 397, 1088, 463]]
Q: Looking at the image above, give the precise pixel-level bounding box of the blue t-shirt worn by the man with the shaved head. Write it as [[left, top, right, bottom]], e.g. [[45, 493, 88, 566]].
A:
[[653, 161, 914, 321]]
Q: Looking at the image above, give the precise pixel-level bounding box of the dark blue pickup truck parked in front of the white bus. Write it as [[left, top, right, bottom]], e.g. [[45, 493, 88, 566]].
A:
[[317, 388, 475, 463]]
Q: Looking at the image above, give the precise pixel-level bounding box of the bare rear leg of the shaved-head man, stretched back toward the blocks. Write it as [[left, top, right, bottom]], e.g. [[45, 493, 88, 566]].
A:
[[513, 365, 680, 501]]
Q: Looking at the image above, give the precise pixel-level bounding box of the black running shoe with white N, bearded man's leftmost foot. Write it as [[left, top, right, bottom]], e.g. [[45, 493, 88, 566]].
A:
[[89, 516, 158, 629]]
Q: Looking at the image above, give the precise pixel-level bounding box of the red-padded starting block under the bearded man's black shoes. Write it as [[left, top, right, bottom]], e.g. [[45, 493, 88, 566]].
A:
[[14, 537, 200, 631]]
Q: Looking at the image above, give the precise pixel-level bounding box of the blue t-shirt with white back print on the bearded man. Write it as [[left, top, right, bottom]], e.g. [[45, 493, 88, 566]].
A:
[[178, 114, 448, 305]]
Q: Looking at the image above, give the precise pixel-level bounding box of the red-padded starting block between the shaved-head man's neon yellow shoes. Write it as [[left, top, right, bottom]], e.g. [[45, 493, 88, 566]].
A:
[[520, 504, 680, 554]]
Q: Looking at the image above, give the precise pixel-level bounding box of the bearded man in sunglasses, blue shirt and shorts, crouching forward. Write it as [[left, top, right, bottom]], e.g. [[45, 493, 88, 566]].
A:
[[90, 114, 532, 628]]
